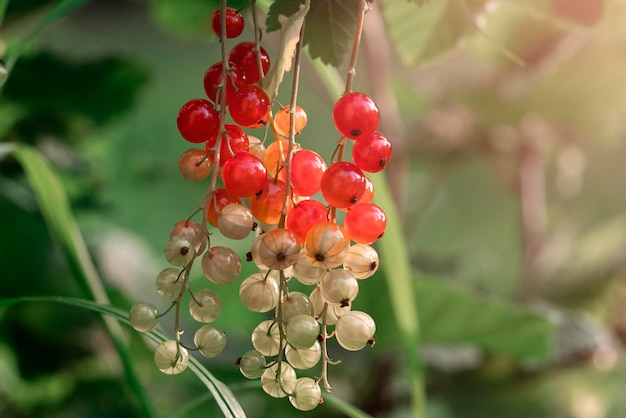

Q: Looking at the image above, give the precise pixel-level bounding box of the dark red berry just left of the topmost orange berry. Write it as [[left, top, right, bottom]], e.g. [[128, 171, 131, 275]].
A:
[[228, 85, 270, 128]]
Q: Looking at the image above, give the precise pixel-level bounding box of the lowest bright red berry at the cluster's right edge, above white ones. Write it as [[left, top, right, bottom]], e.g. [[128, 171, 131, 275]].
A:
[[343, 202, 387, 245]]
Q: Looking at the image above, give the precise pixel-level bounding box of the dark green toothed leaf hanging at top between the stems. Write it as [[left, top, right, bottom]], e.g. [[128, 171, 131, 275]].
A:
[[265, 0, 359, 67]]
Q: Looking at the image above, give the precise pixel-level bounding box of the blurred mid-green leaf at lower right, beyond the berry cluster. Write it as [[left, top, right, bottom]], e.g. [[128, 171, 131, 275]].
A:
[[417, 279, 556, 361]]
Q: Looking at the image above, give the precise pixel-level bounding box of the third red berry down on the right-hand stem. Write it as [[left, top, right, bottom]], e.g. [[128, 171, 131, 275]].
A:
[[320, 161, 365, 209]]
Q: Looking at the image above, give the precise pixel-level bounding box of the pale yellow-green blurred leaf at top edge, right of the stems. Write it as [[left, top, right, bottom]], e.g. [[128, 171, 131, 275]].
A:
[[381, 0, 484, 66]]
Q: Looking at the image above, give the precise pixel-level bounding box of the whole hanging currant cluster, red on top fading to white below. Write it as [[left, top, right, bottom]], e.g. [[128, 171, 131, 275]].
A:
[[130, 1, 391, 410]]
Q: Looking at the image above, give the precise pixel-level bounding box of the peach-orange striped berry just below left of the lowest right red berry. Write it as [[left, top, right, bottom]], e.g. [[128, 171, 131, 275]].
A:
[[304, 222, 350, 269]]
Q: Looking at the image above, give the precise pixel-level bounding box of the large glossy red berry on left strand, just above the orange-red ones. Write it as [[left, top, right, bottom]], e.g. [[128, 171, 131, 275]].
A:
[[222, 152, 267, 197]]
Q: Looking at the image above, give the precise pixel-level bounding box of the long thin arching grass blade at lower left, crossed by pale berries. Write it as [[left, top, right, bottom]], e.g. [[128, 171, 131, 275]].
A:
[[0, 296, 246, 418]]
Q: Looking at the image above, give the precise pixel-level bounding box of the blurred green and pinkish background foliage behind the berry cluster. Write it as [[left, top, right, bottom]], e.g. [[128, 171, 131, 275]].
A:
[[0, 0, 626, 418]]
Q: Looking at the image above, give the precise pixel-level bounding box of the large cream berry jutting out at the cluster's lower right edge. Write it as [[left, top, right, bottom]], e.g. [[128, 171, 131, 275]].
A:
[[335, 311, 376, 351]]
